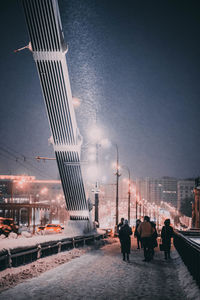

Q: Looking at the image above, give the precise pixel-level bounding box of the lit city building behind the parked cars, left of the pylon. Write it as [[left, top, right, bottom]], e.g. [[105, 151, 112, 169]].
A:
[[0, 175, 67, 226]]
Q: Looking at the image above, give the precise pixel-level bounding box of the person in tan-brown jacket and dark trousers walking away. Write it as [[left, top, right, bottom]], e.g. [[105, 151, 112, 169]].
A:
[[138, 216, 155, 261]]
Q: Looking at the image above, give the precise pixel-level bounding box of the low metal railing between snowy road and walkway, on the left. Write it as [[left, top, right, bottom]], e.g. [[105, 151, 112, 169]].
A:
[[0, 234, 107, 271]]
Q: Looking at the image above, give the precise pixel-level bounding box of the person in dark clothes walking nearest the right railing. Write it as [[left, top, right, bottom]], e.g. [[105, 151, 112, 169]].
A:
[[161, 219, 174, 259]]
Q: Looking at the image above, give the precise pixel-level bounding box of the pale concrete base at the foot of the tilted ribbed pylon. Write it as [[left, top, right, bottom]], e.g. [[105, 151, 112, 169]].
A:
[[64, 220, 95, 237]]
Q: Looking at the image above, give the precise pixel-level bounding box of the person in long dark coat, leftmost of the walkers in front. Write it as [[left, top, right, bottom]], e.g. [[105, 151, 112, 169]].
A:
[[119, 220, 132, 262]]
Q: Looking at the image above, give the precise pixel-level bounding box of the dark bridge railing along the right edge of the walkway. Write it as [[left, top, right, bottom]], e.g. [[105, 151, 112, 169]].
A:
[[174, 232, 200, 287]]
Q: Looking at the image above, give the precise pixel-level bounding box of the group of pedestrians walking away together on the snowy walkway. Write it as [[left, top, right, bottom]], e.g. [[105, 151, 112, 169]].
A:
[[117, 216, 174, 262]]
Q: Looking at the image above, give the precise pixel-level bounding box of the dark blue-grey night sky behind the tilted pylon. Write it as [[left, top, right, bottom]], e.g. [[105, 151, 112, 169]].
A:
[[0, 0, 200, 178]]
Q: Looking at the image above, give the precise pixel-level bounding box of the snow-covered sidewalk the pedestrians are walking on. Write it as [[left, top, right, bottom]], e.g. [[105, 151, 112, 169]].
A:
[[0, 237, 200, 300]]
